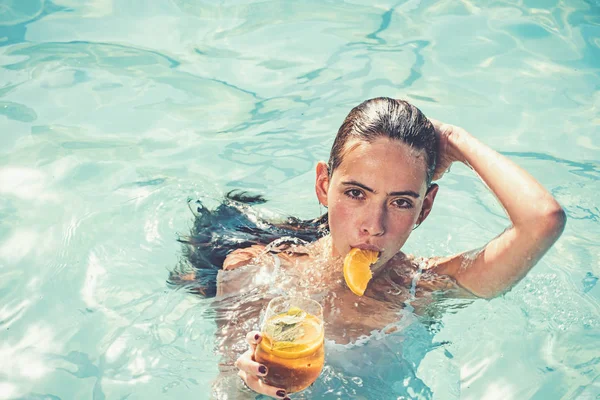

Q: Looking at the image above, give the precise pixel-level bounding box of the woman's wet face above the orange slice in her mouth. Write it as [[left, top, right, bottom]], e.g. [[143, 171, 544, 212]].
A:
[[316, 138, 437, 268]]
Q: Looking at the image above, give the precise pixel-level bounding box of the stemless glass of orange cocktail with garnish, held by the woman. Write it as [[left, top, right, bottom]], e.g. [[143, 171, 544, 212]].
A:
[[254, 297, 325, 393]]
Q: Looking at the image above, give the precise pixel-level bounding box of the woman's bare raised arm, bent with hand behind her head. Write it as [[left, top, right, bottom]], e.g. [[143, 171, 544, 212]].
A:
[[431, 120, 566, 298]]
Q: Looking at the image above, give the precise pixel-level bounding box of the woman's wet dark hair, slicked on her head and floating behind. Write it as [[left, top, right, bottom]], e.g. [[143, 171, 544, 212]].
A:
[[168, 97, 438, 297]]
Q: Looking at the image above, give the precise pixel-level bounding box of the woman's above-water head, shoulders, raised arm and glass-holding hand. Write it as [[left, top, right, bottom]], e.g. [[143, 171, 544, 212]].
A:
[[172, 98, 566, 398]]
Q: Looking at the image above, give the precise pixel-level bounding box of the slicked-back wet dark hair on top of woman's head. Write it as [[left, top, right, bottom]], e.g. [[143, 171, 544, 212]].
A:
[[328, 97, 438, 185]]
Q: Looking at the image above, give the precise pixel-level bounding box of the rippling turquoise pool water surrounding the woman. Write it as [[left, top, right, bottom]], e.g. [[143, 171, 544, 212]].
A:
[[0, 0, 600, 400]]
